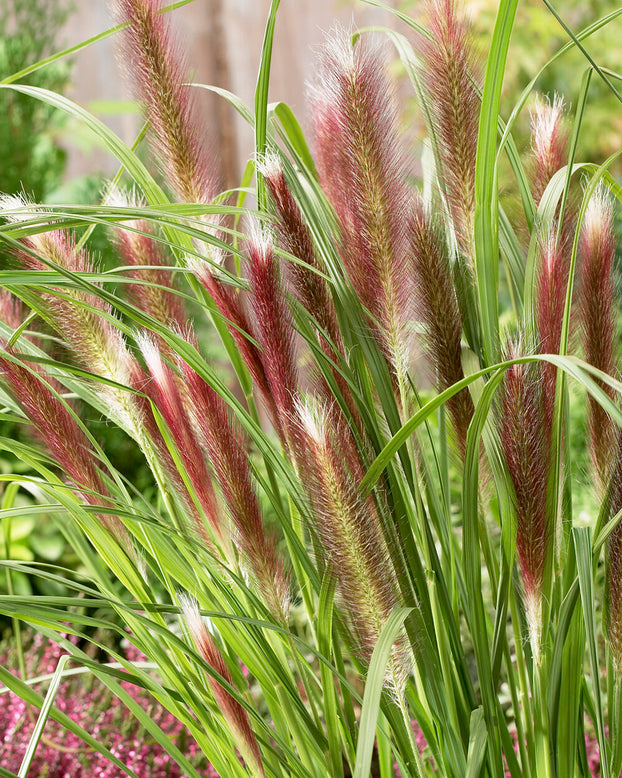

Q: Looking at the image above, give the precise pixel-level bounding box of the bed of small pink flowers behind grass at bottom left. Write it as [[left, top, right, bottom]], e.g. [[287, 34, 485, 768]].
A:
[[0, 636, 218, 778]]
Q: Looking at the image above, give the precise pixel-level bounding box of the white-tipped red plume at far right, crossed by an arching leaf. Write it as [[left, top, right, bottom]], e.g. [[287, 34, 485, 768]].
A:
[[578, 188, 617, 493]]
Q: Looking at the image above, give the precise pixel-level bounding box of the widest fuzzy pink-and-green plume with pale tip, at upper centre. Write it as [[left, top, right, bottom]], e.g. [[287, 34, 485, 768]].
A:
[[312, 31, 412, 379]]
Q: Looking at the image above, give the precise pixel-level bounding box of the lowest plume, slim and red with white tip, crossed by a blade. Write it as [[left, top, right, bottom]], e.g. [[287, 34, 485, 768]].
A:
[[179, 595, 266, 778]]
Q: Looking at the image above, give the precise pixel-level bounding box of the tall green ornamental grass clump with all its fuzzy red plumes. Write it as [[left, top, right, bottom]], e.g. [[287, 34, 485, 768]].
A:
[[0, 0, 622, 778]]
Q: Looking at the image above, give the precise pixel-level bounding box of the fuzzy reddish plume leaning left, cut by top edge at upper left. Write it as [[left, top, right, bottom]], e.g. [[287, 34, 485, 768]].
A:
[[112, 0, 215, 203]]
